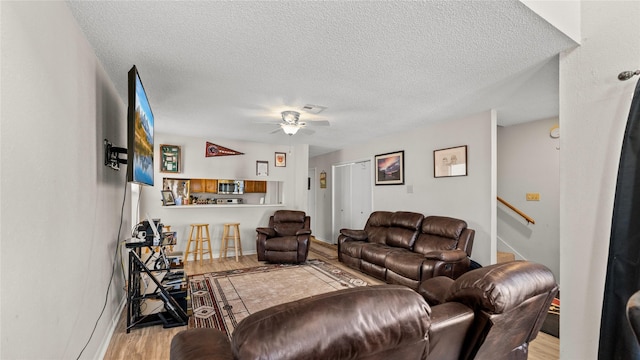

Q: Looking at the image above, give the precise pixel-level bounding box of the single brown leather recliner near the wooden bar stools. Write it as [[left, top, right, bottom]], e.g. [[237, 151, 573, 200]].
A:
[[256, 210, 311, 263]]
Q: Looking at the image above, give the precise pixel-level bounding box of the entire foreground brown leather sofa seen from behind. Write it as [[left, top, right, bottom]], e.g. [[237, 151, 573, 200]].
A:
[[170, 262, 557, 360]]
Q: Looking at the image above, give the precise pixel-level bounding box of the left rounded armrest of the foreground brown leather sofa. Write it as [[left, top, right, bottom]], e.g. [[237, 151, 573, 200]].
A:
[[169, 328, 233, 360]]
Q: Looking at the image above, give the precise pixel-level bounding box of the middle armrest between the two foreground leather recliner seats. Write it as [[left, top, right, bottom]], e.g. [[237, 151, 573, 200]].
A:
[[429, 302, 474, 360]]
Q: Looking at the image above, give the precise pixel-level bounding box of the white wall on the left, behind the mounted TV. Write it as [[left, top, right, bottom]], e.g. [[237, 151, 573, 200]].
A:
[[0, 1, 130, 359]]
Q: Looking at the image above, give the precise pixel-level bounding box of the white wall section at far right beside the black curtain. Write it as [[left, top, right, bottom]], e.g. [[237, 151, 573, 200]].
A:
[[560, 1, 640, 359]]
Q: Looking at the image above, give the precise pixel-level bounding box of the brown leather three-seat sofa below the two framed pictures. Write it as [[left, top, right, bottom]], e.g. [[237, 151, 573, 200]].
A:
[[338, 211, 475, 290]]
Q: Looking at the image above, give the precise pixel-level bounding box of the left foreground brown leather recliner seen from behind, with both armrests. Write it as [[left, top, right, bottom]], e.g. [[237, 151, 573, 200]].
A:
[[170, 285, 473, 360]]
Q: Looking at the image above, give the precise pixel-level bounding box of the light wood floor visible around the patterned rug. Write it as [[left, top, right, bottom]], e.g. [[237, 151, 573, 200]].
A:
[[104, 252, 560, 360]]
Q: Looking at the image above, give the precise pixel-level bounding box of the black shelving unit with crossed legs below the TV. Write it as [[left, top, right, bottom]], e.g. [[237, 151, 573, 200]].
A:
[[126, 239, 189, 333]]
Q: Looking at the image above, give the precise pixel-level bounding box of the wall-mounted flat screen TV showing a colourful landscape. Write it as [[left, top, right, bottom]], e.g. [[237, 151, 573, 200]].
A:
[[127, 65, 154, 186]]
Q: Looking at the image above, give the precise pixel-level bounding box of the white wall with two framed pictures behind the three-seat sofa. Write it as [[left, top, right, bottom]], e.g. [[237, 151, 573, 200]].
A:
[[309, 112, 495, 265]]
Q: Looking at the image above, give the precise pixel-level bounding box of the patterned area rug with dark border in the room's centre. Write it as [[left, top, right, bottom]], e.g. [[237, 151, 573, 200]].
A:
[[189, 260, 369, 337]]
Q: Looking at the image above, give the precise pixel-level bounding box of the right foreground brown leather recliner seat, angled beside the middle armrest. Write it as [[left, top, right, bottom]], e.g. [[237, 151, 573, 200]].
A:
[[418, 261, 558, 360]]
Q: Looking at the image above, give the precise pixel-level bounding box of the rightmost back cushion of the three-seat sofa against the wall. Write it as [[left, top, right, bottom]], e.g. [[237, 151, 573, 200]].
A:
[[413, 216, 467, 254]]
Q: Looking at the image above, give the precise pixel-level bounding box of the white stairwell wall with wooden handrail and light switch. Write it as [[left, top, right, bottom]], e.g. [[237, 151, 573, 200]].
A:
[[498, 118, 560, 281]]
